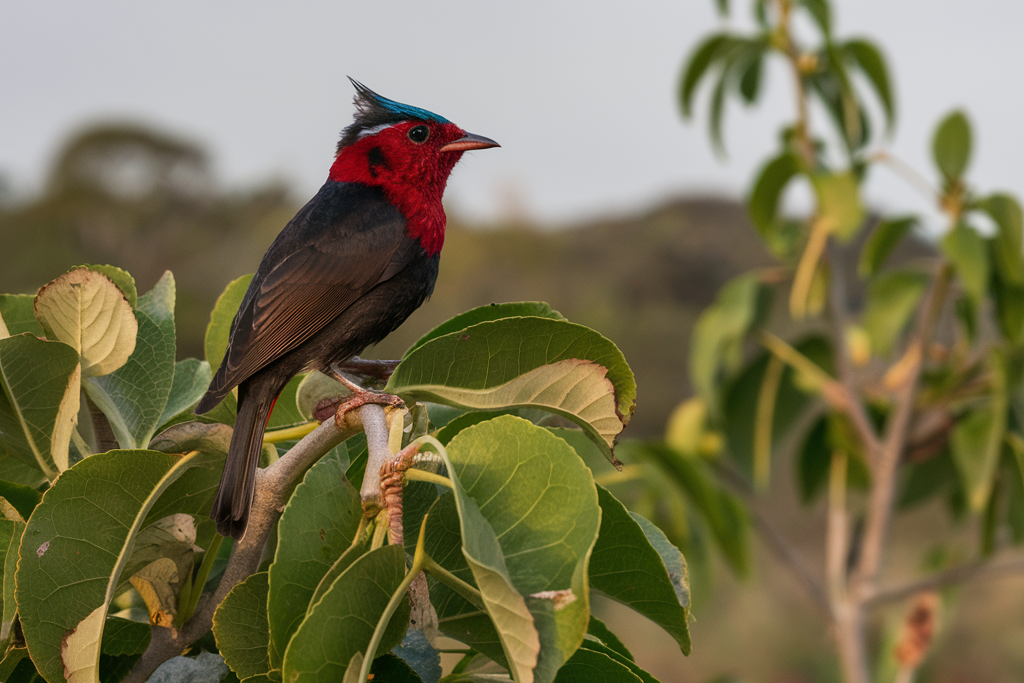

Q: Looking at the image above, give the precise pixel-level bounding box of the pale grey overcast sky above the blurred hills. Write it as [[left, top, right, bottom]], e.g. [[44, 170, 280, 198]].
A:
[[0, 0, 1024, 232]]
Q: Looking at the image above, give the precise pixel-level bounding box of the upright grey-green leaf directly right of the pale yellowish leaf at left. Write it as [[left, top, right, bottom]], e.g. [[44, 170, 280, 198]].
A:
[[85, 271, 175, 449]]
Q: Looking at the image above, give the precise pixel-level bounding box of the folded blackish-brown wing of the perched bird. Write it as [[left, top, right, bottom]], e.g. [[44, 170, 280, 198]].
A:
[[204, 188, 421, 402]]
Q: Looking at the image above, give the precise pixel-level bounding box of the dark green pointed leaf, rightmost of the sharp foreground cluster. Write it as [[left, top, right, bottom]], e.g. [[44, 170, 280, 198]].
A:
[[590, 486, 690, 654]]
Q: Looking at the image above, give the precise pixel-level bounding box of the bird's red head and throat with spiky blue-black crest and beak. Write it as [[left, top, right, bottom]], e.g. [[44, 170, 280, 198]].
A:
[[329, 79, 499, 252]]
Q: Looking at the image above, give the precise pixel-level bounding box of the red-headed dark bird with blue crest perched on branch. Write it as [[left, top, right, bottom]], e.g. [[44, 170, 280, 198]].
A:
[[195, 78, 500, 539]]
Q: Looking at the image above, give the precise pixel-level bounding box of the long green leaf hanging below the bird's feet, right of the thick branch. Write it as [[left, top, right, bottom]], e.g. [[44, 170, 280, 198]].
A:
[[267, 451, 362, 668]]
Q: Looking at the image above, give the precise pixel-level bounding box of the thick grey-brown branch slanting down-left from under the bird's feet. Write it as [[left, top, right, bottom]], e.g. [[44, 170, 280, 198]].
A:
[[123, 405, 387, 683]]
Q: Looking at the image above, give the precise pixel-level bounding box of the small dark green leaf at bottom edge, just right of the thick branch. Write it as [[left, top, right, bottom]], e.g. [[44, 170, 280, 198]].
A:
[[213, 571, 270, 680]]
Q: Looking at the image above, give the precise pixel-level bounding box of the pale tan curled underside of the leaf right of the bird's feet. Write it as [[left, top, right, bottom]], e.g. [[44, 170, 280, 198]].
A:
[[401, 358, 624, 453]]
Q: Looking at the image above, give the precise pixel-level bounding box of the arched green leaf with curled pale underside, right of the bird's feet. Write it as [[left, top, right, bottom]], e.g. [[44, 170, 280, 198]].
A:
[[386, 317, 636, 459]]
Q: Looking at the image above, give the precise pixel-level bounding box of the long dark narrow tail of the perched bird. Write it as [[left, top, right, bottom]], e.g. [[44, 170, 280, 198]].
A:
[[210, 383, 278, 540]]
